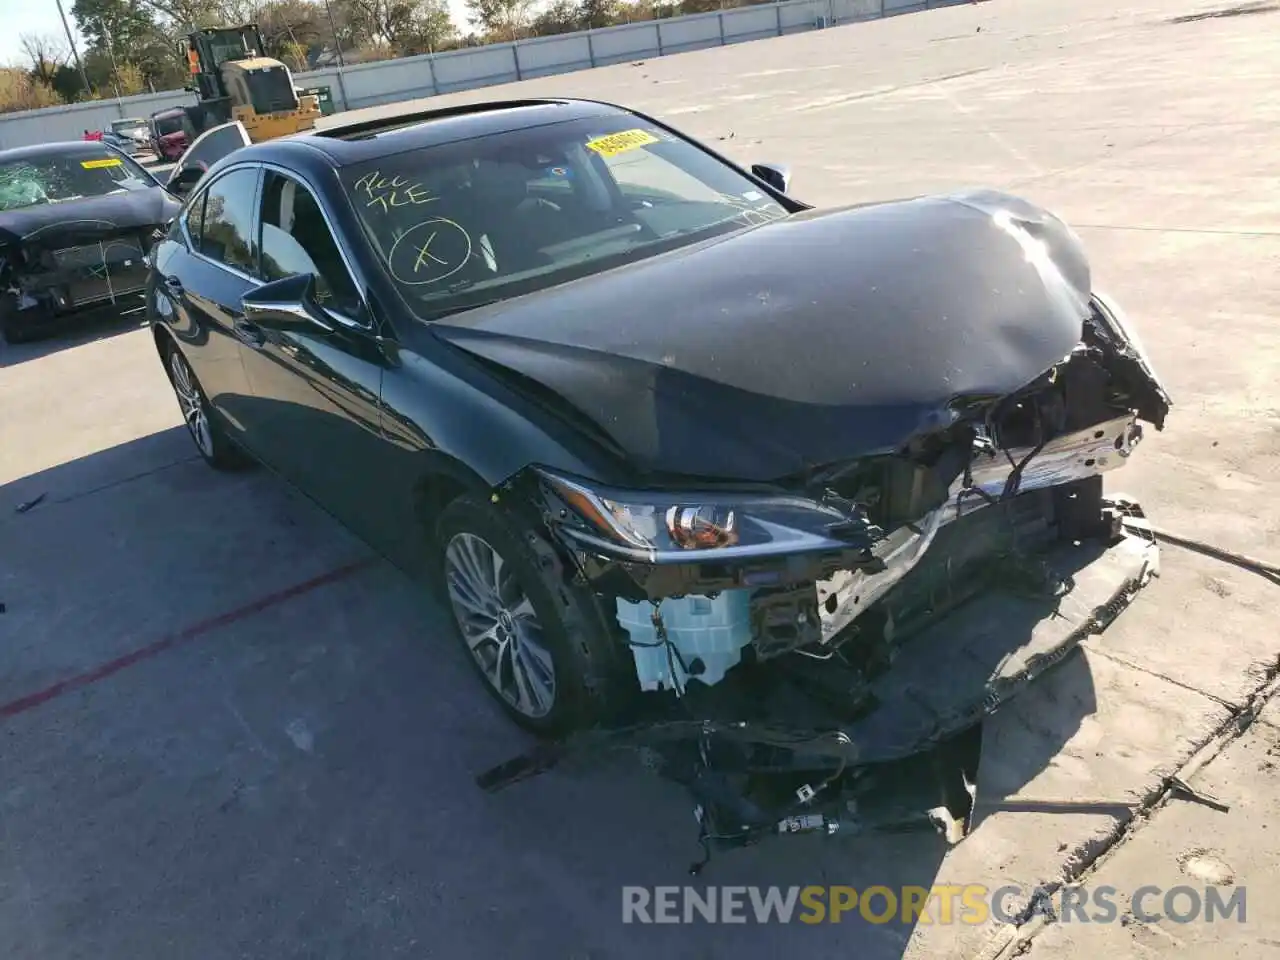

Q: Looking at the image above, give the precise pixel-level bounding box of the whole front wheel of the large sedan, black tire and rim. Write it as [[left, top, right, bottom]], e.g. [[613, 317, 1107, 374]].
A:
[[431, 495, 639, 736]]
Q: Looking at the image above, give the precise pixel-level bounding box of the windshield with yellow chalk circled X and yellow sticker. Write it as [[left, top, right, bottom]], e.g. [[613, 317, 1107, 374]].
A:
[[342, 116, 787, 320]]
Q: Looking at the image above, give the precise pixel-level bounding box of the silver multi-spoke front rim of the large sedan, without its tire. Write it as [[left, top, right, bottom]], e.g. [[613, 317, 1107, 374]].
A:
[[444, 534, 556, 718]]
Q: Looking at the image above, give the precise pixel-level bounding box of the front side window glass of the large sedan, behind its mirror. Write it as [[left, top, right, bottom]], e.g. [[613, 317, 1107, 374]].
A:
[[261, 170, 360, 315]]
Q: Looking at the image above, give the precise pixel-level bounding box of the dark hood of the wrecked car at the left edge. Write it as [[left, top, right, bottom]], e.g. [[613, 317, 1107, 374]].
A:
[[0, 187, 182, 246]]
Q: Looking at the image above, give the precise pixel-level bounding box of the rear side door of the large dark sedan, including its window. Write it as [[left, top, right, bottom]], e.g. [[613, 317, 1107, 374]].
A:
[[155, 166, 261, 452]]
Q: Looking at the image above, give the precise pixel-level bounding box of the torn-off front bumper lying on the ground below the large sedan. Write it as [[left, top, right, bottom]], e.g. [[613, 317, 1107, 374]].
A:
[[477, 496, 1160, 867]]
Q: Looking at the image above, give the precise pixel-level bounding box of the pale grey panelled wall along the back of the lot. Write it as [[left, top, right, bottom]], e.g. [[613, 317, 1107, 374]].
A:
[[0, 0, 966, 148]]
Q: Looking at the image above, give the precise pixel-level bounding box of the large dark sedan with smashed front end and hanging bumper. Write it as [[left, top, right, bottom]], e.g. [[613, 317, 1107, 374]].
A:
[[148, 100, 1170, 842]]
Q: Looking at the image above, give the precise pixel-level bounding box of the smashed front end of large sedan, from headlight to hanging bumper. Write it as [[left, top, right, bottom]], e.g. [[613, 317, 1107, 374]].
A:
[[480, 296, 1171, 865]]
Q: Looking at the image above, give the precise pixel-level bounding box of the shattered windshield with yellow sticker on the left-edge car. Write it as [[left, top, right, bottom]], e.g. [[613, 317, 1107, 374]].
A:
[[0, 151, 156, 211]]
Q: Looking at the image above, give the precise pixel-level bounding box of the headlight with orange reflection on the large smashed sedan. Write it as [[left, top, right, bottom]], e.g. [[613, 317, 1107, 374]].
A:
[[538, 470, 876, 563]]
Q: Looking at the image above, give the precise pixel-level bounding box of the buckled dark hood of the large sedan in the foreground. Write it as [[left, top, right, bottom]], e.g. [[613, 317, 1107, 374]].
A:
[[431, 191, 1091, 481]]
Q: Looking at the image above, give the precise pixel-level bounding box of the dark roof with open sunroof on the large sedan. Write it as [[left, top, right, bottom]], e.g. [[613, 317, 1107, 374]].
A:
[[234, 99, 630, 166]]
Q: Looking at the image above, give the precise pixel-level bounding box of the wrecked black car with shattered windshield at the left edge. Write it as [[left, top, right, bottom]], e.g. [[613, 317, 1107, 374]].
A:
[[0, 141, 180, 343]]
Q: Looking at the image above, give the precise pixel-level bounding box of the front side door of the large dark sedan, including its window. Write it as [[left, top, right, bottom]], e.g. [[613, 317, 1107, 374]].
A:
[[235, 168, 401, 545]]
